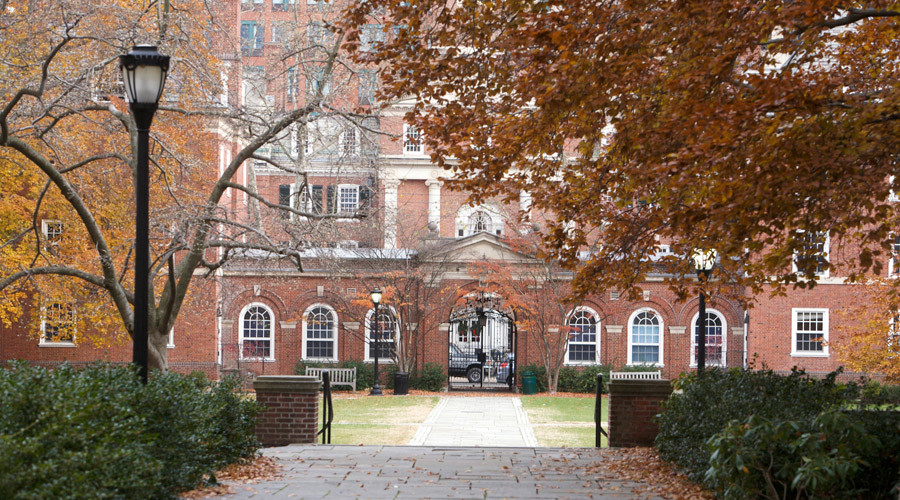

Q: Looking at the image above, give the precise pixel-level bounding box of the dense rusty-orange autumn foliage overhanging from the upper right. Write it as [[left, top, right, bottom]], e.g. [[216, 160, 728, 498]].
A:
[[345, 0, 900, 296]]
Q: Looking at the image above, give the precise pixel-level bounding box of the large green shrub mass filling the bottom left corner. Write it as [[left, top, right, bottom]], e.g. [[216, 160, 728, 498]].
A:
[[0, 363, 260, 499]]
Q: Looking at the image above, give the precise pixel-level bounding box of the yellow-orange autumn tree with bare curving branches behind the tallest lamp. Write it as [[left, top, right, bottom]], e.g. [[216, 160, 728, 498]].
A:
[[0, 0, 376, 370]]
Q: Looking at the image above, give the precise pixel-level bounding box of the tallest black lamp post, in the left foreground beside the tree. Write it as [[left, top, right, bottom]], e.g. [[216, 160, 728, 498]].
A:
[[119, 45, 169, 384]]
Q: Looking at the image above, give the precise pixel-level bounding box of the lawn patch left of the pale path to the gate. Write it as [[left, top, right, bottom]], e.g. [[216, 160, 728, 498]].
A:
[[319, 394, 438, 445]]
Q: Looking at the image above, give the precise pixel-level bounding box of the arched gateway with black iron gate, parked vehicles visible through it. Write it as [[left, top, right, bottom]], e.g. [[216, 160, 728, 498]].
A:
[[447, 292, 517, 390]]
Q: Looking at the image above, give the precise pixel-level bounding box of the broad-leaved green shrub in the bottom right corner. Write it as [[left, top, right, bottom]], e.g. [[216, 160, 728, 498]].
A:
[[706, 410, 900, 499]]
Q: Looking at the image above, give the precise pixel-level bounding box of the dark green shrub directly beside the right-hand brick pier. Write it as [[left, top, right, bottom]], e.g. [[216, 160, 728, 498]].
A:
[[656, 368, 849, 482]]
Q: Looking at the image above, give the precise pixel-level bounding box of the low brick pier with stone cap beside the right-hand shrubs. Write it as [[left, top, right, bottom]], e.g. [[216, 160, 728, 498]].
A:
[[609, 380, 672, 448]]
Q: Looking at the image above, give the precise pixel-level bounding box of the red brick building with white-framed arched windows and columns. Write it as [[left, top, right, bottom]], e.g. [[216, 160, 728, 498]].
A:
[[0, 0, 872, 384]]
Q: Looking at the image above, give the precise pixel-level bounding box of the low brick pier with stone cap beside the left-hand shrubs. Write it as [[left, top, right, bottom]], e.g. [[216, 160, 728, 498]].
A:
[[253, 376, 322, 446]]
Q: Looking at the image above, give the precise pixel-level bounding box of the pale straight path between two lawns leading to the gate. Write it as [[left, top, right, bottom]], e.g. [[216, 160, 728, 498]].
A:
[[409, 397, 537, 447]]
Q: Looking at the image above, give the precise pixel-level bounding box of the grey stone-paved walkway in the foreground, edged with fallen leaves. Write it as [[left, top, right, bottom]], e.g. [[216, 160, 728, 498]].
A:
[[223, 446, 659, 500]]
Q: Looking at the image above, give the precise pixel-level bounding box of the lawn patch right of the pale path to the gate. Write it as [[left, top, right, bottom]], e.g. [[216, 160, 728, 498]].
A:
[[522, 396, 609, 447]]
